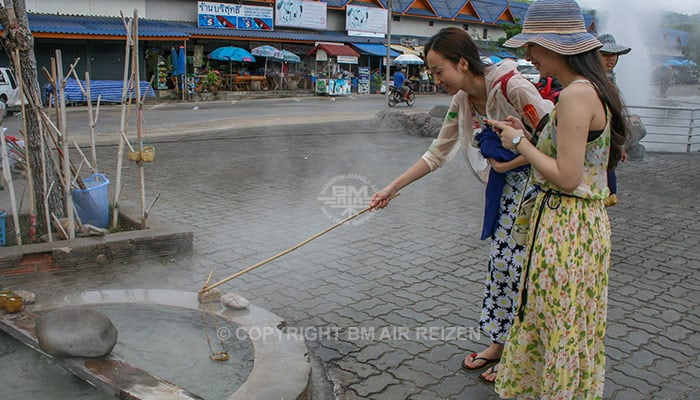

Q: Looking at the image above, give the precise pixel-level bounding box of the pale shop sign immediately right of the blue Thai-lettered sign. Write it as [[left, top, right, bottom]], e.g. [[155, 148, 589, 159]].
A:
[[275, 0, 328, 30]]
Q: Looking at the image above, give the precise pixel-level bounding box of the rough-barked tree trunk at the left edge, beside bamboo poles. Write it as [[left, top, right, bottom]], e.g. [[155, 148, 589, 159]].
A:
[[0, 0, 65, 233]]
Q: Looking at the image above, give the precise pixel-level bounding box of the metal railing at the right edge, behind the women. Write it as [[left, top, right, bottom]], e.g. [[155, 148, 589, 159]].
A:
[[627, 105, 700, 153]]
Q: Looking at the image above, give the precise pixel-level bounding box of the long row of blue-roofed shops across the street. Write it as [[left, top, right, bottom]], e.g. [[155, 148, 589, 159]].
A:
[[0, 0, 592, 90]]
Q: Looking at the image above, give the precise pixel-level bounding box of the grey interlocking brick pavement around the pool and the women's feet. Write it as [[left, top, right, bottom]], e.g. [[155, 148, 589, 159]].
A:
[[0, 99, 700, 400]]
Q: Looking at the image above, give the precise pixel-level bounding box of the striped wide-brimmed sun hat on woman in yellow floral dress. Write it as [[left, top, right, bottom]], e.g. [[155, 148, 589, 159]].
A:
[[504, 0, 602, 56]]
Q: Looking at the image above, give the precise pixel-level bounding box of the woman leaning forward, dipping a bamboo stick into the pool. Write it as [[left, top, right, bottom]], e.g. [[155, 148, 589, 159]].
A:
[[369, 28, 553, 383]]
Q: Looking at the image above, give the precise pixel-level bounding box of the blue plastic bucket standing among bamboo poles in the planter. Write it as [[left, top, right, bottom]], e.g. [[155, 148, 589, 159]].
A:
[[73, 174, 109, 228]]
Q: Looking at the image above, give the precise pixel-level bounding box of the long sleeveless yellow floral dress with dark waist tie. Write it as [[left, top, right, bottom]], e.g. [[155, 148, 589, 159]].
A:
[[496, 104, 611, 400]]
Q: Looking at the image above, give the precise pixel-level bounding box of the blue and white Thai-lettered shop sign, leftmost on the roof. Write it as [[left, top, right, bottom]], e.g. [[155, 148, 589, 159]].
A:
[[197, 1, 274, 31]]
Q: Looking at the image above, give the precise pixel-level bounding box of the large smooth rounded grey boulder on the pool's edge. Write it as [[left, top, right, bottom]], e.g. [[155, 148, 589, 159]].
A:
[[34, 307, 117, 357]]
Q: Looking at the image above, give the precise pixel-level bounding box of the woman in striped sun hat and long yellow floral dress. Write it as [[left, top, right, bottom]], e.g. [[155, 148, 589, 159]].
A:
[[492, 0, 628, 399]]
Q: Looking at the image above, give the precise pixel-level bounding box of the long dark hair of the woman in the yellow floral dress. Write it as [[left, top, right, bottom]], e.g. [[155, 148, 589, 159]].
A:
[[565, 50, 629, 170]]
